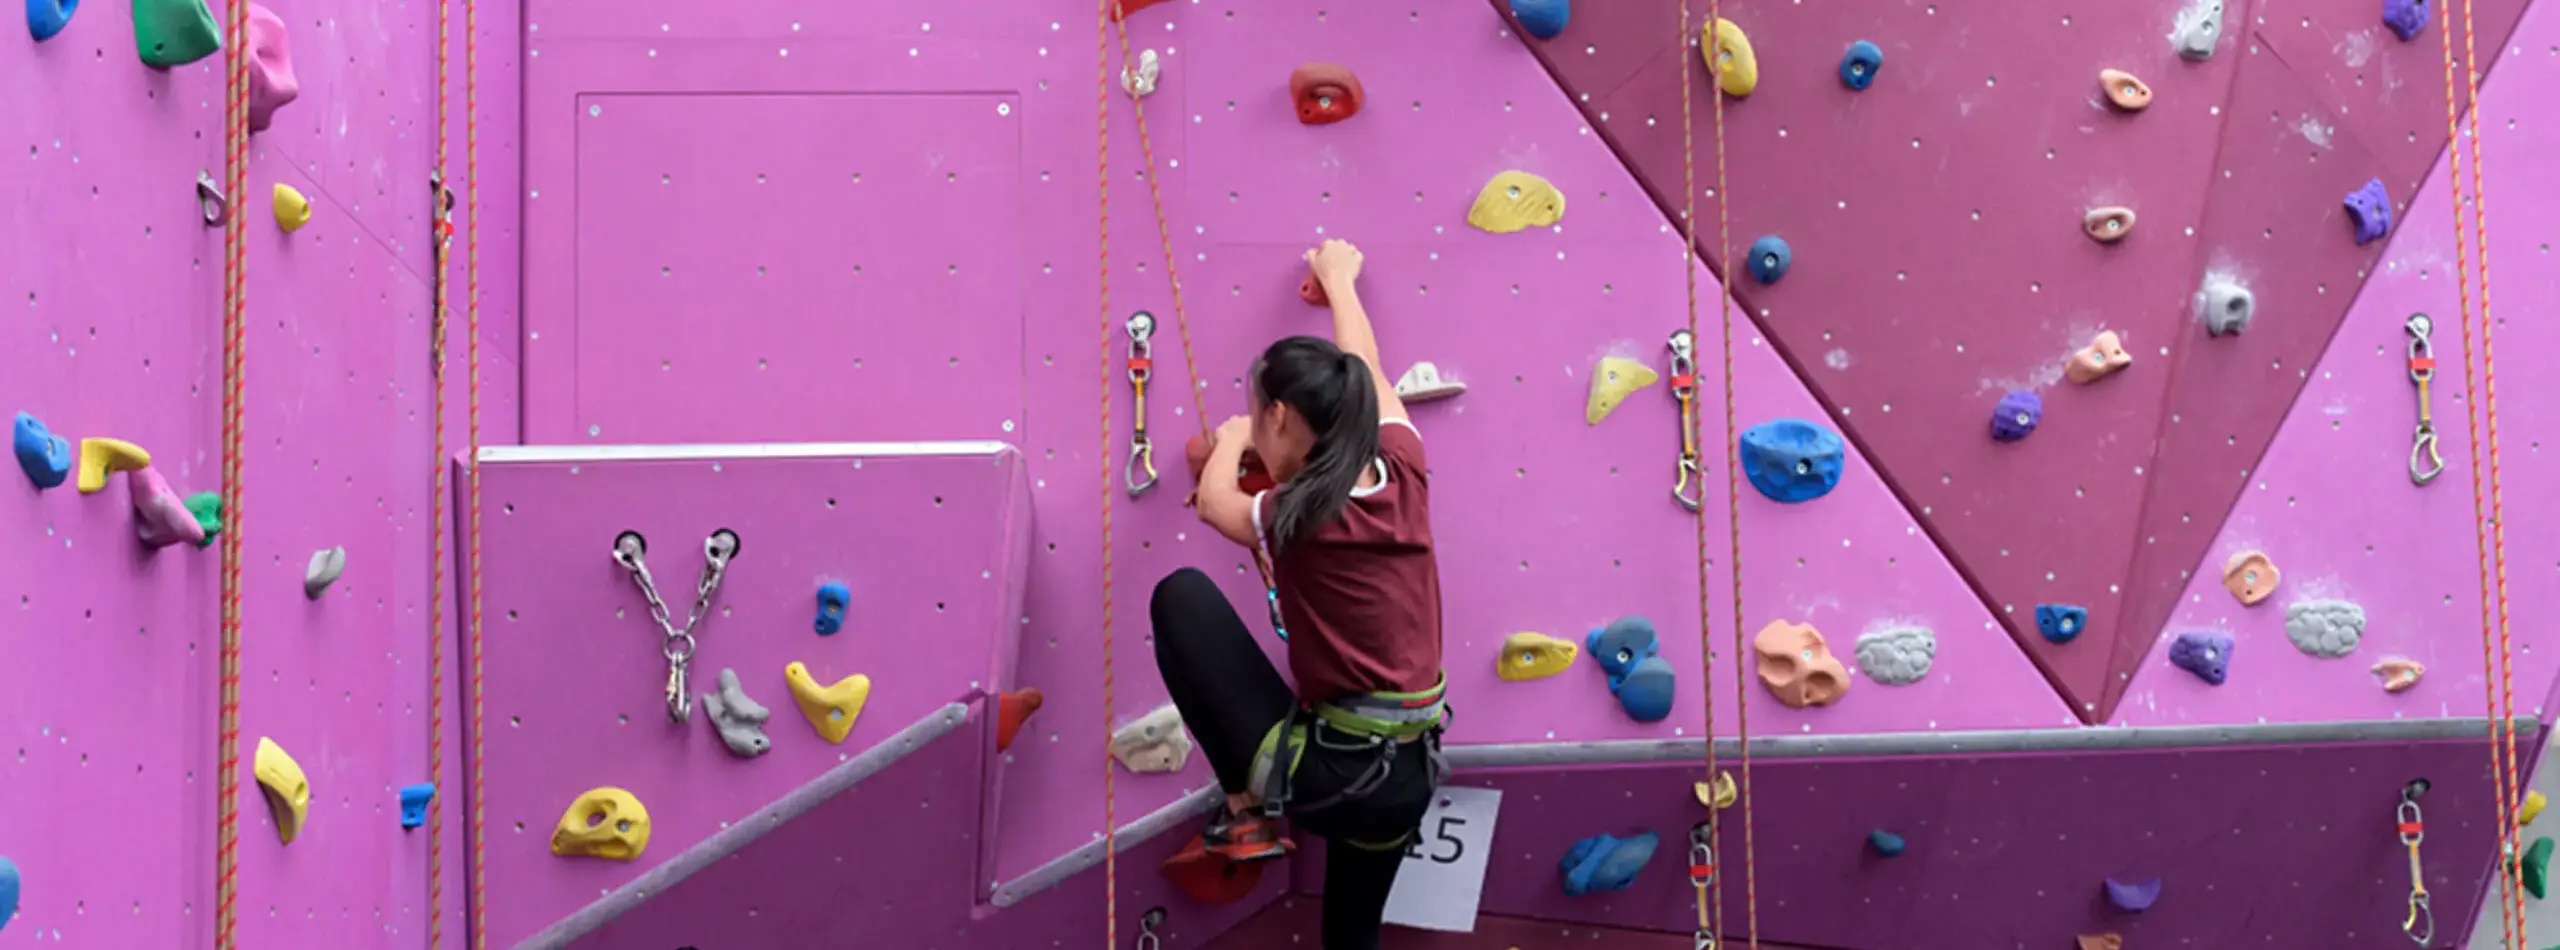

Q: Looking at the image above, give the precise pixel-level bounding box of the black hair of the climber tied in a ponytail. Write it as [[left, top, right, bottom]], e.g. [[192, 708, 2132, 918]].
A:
[[1254, 335, 1377, 553]]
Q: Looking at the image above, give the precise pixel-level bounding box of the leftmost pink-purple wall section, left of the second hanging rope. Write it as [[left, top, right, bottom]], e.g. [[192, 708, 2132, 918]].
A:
[[0, 0, 433, 947]]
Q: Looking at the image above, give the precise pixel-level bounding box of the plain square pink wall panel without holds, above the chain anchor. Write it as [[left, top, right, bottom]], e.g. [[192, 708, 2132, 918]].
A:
[[563, 95, 1024, 443]]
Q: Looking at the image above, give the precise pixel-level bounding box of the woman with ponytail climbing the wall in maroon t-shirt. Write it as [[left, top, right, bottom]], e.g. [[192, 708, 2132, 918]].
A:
[[1149, 241, 1444, 950]]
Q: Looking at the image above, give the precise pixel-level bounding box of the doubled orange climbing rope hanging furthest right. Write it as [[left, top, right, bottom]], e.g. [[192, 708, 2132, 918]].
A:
[[2412, 0, 2527, 950]]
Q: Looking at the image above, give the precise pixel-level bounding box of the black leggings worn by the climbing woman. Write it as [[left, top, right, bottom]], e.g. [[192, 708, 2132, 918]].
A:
[[1147, 568, 1431, 950]]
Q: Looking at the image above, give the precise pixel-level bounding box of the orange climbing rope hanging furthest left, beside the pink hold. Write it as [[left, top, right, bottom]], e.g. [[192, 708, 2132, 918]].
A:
[[212, 0, 248, 950]]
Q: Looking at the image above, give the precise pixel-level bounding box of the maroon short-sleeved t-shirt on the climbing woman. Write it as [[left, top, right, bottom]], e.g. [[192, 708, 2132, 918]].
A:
[[1254, 420, 1441, 702]]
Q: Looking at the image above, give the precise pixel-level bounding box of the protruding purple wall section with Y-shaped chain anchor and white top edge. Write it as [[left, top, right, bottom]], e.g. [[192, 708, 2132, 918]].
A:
[[481, 443, 1029, 945]]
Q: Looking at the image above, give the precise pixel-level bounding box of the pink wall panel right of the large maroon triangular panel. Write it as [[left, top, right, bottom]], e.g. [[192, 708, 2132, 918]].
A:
[[2117, 8, 2560, 725]]
